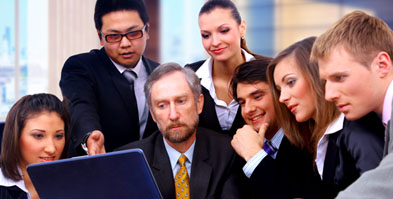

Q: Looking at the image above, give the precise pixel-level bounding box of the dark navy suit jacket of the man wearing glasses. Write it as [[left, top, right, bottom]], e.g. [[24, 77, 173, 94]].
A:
[[60, 48, 158, 156]]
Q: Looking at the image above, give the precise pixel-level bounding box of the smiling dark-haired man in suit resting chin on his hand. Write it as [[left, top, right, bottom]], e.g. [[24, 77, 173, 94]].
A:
[[231, 58, 317, 198]]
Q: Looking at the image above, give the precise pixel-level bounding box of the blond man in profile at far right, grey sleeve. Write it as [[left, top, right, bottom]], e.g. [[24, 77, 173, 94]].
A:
[[311, 11, 393, 198]]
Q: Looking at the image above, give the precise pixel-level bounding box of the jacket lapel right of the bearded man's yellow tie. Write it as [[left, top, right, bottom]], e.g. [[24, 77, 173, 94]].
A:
[[190, 132, 213, 198]]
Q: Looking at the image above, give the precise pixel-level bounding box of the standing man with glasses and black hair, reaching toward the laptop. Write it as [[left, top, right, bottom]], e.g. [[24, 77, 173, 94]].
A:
[[60, 0, 158, 156]]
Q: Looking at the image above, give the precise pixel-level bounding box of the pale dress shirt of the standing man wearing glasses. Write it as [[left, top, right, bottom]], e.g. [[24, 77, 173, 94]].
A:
[[111, 58, 149, 139]]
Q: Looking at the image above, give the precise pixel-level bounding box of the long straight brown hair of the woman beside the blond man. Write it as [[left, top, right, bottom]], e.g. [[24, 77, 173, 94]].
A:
[[267, 37, 339, 158]]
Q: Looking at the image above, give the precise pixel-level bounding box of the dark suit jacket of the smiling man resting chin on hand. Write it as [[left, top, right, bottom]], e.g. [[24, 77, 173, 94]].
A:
[[250, 136, 320, 199]]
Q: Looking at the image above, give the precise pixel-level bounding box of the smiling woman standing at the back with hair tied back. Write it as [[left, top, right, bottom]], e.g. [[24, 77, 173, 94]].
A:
[[186, 0, 266, 136]]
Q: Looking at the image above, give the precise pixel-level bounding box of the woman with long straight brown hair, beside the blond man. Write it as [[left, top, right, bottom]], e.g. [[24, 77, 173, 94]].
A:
[[268, 37, 384, 198]]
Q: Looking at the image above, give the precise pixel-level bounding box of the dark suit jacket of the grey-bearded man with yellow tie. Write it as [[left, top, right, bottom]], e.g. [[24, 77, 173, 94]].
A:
[[115, 128, 244, 199]]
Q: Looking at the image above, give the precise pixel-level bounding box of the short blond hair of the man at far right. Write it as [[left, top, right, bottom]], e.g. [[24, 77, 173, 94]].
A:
[[310, 11, 393, 67]]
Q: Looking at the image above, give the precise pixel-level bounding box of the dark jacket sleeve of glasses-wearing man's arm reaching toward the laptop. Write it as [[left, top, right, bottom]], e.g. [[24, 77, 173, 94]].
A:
[[60, 54, 101, 155]]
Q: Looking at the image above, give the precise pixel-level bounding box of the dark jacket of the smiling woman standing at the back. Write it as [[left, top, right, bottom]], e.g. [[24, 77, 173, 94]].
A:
[[185, 61, 245, 137]]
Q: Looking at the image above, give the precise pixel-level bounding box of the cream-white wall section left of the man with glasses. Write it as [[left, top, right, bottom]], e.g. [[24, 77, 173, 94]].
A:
[[48, 0, 100, 97]]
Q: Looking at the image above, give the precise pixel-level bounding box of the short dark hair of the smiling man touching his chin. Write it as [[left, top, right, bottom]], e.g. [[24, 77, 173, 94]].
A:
[[230, 56, 272, 100]]
